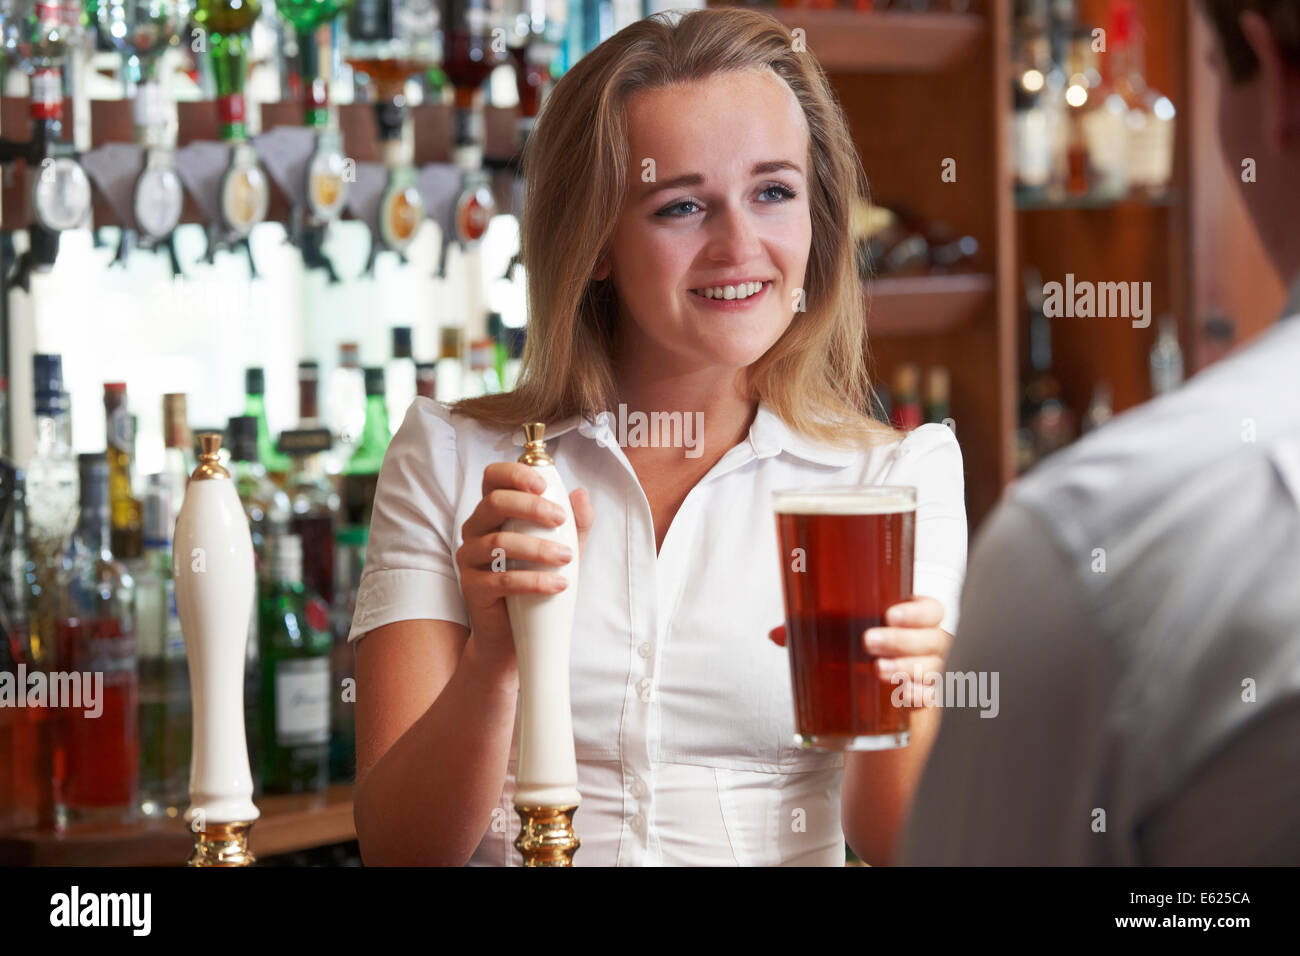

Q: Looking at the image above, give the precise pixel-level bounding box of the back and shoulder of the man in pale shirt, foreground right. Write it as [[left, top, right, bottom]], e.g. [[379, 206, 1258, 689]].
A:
[[900, 310, 1300, 864]]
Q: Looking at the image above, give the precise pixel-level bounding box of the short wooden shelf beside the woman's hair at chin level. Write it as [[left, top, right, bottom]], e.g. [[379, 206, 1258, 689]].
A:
[[867, 273, 993, 338]]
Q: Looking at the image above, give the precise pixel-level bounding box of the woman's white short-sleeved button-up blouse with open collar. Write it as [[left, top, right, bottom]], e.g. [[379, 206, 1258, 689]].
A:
[[348, 398, 967, 866]]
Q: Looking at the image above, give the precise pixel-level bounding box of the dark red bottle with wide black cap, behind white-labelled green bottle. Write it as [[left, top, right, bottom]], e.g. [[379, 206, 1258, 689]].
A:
[[280, 428, 339, 602]]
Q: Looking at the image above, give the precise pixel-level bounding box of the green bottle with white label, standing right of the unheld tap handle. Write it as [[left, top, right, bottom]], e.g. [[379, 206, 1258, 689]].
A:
[[259, 535, 332, 793]]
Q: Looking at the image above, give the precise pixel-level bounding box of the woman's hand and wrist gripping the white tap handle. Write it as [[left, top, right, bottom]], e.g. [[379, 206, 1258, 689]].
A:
[[456, 462, 595, 663]]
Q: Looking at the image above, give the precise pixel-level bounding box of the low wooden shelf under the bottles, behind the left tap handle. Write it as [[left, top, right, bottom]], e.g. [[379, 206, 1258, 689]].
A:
[[0, 783, 356, 866]]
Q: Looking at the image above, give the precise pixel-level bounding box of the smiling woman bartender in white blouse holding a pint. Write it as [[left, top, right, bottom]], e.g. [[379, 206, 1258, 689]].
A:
[[350, 9, 966, 866]]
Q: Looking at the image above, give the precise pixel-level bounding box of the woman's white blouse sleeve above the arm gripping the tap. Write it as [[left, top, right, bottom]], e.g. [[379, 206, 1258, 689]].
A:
[[347, 398, 469, 641]]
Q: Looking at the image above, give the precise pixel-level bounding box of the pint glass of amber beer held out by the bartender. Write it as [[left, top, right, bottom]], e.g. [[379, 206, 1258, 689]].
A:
[[772, 486, 917, 750]]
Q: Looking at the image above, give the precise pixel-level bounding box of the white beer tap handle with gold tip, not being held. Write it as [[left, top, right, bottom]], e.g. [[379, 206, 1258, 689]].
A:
[[172, 432, 259, 866]]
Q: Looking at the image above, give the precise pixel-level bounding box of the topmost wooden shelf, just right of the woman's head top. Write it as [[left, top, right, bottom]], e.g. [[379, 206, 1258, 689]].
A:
[[763, 7, 987, 73]]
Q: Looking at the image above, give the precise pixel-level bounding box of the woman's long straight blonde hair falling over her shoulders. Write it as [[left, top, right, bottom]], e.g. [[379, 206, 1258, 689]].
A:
[[452, 8, 898, 447]]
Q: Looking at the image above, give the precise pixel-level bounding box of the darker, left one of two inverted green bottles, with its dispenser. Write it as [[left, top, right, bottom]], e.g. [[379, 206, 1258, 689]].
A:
[[194, 0, 270, 239]]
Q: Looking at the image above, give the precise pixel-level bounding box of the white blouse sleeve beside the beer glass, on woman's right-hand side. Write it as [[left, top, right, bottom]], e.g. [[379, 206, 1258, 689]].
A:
[[881, 423, 967, 635]]
